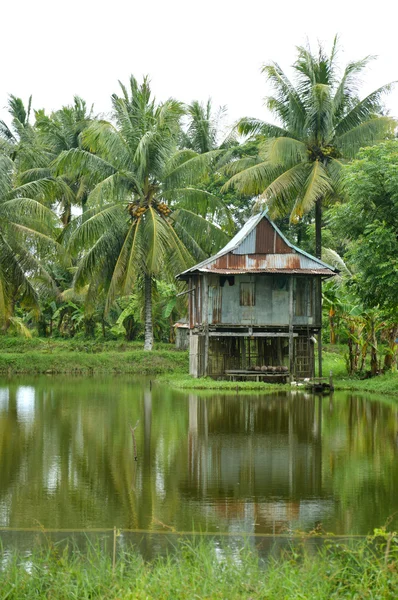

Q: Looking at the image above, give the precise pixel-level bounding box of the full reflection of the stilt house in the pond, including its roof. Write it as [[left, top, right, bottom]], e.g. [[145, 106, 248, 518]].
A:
[[180, 395, 331, 533]]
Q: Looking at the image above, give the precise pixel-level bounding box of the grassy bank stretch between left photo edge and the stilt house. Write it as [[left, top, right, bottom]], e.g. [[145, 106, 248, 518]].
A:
[[0, 337, 188, 375]]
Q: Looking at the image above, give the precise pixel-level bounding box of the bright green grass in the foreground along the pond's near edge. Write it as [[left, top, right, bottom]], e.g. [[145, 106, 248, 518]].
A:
[[0, 538, 398, 600]]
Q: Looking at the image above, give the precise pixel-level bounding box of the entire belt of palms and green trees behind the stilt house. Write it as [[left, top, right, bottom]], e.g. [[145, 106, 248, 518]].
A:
[[0, 50, 398, 356]]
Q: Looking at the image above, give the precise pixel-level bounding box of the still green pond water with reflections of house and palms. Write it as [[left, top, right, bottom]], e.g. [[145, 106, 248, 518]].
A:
[[0, 377, 398, 534]]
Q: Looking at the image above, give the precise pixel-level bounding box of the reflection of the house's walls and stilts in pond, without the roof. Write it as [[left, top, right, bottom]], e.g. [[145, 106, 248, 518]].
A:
[[189, 396, 322, 499]]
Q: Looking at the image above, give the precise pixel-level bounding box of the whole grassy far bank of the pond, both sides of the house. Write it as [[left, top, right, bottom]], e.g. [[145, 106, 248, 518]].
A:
[[0, 336, 398, 396]]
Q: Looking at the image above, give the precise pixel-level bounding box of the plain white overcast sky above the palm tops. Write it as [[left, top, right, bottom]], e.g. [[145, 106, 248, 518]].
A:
[[0, 0, 398, 129]]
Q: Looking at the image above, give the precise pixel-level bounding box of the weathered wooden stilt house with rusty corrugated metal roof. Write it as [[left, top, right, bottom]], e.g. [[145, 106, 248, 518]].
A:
[[177, 212, 337, 381]]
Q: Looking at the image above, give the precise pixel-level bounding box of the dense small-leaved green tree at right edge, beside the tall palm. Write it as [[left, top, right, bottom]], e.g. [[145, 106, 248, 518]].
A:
[[329, 141, 398, 311]]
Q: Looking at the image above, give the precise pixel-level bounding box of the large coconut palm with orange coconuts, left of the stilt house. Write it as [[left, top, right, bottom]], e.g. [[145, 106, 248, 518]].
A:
[[57, 77, 226, 350]]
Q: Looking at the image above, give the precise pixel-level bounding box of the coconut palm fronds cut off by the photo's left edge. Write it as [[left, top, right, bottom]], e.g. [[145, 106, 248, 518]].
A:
[[0, 154, 62, 330]]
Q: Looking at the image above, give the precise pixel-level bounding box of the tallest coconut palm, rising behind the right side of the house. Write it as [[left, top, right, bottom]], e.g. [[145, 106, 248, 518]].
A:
[[224, 38, 395, 257]]
